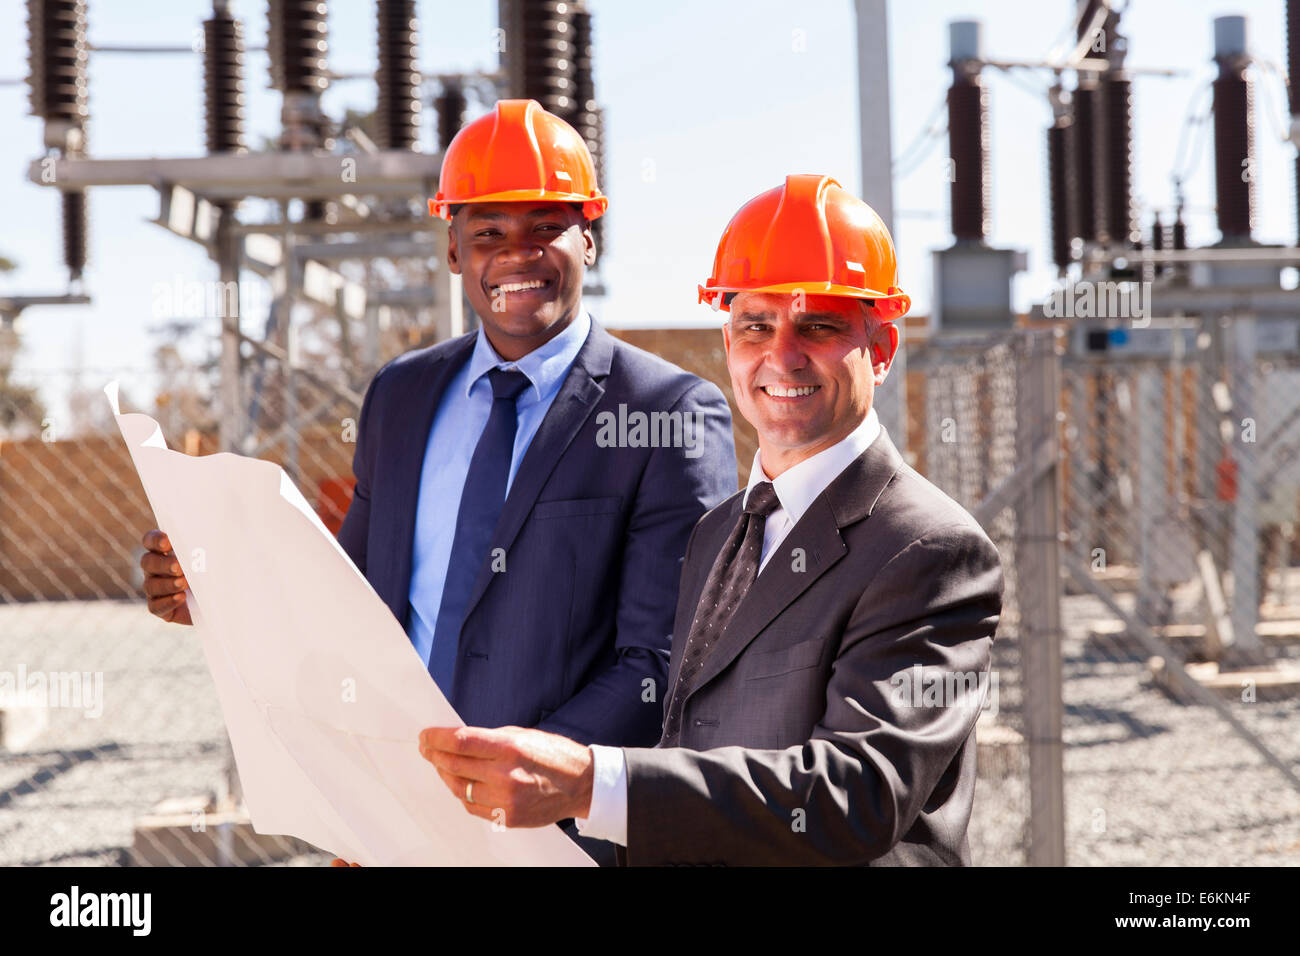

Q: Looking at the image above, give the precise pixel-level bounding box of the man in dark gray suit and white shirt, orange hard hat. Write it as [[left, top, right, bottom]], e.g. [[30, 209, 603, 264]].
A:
[[420, 176, 1002, 865]]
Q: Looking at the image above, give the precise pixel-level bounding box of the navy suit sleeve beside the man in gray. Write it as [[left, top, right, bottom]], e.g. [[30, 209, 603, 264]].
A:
[[538, 381, 736, 747]]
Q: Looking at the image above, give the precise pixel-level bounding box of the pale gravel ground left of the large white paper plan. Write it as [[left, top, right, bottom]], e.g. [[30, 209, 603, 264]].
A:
[[0, 601, 329, 866]]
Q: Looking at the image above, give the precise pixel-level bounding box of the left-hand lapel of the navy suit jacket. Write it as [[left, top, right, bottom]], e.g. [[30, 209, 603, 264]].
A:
[[371, 332, 477, 627]]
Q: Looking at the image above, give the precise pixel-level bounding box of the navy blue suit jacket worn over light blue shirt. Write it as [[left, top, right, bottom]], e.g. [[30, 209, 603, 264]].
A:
[[338, 321, 736, 747]]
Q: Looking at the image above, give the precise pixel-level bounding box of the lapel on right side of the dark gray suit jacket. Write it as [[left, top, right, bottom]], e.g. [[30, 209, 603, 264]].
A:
[[670, 428, 902, 695]]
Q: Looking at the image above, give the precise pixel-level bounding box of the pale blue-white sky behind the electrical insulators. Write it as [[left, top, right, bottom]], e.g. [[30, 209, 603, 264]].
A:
[[0, 0, 1295, 403]]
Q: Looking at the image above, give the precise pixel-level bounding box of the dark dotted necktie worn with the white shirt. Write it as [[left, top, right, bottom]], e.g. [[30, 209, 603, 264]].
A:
[[663, 481, 781, 747]]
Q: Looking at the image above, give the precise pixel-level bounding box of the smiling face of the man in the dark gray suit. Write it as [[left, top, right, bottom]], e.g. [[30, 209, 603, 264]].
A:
[[723, 293, 898, 477]]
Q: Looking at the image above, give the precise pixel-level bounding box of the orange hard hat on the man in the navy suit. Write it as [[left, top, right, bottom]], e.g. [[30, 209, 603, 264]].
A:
[[429, 100, 610, 220]]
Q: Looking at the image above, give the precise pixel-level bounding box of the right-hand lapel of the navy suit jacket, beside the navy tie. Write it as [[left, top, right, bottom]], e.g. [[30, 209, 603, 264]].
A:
[[462, 320, 614, 624]]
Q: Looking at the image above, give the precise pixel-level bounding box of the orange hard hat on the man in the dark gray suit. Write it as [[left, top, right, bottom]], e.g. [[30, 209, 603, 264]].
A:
[[699, 174, 911, 321]]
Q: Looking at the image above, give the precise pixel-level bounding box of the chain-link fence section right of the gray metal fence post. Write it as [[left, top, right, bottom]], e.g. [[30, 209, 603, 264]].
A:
[[1062, 317, 1300, 865]]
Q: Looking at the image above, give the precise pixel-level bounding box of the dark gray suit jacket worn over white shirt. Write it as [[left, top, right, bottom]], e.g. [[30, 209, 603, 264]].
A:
[[621, 429, 1002, 866]]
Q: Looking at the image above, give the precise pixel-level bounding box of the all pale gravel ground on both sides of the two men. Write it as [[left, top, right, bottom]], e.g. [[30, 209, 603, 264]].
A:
[[0, 597, 1300, 866]]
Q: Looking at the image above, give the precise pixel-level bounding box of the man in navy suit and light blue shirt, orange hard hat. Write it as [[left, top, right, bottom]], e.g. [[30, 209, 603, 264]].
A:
[[142, 100, 736, 858]]
